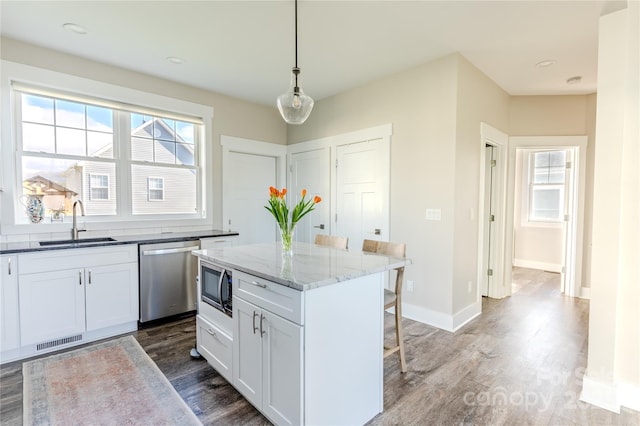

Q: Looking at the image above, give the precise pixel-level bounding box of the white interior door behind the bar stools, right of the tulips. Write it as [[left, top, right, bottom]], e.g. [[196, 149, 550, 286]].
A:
[[335, 139, 389, 250]]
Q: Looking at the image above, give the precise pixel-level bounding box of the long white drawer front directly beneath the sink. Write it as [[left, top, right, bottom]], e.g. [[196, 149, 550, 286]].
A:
[[20, 244, 138, 275]]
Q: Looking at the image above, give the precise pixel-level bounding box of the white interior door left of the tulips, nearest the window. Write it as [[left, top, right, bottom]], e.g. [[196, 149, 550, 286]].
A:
[[223, 151, 278, 245]]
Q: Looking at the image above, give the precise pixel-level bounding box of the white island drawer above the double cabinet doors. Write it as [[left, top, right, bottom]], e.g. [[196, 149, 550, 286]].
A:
[[233, 271, 304, 325]]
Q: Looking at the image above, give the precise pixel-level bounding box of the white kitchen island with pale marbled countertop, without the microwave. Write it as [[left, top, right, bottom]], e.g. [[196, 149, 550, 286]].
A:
[[194, 243, 410, 425]]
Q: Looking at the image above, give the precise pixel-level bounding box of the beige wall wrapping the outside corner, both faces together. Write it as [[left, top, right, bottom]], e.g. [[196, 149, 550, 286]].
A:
[[289, 54, 509, 326]]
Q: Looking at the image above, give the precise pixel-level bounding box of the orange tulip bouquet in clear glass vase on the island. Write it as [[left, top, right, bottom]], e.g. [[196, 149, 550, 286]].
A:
[[264, 186, 322, 254]]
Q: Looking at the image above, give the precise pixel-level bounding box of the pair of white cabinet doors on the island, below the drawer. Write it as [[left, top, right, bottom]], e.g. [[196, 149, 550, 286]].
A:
[[233, 297, 303, 425]]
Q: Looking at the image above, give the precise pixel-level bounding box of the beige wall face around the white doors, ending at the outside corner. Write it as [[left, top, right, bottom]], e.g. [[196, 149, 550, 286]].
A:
[[289, 55, 458, 314]]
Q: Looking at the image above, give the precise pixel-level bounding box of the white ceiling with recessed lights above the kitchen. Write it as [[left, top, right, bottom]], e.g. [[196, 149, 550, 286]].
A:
[[0, 0, 626, 105]]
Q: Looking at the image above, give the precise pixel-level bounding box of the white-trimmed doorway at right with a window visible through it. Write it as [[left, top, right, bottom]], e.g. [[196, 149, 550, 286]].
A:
[[505, 136, 587, 297]]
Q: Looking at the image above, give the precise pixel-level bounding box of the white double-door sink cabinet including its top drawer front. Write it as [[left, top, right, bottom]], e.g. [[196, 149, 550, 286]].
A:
[[19, 245, 138, 351]]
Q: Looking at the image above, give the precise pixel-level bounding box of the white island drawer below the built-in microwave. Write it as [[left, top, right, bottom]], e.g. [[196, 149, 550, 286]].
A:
[[196, 315, 233, 382]]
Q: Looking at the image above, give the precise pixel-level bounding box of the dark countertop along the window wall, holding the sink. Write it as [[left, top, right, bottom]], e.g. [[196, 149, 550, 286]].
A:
[[0, 229, 238, 254]]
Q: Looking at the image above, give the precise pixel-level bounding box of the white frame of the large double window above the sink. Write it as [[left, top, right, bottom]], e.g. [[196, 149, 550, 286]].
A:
[[0, 60, 213, 235]]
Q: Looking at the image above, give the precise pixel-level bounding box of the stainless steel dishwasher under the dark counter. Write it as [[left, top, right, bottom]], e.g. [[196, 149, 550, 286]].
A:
[[139, 240, 200, 323]]
